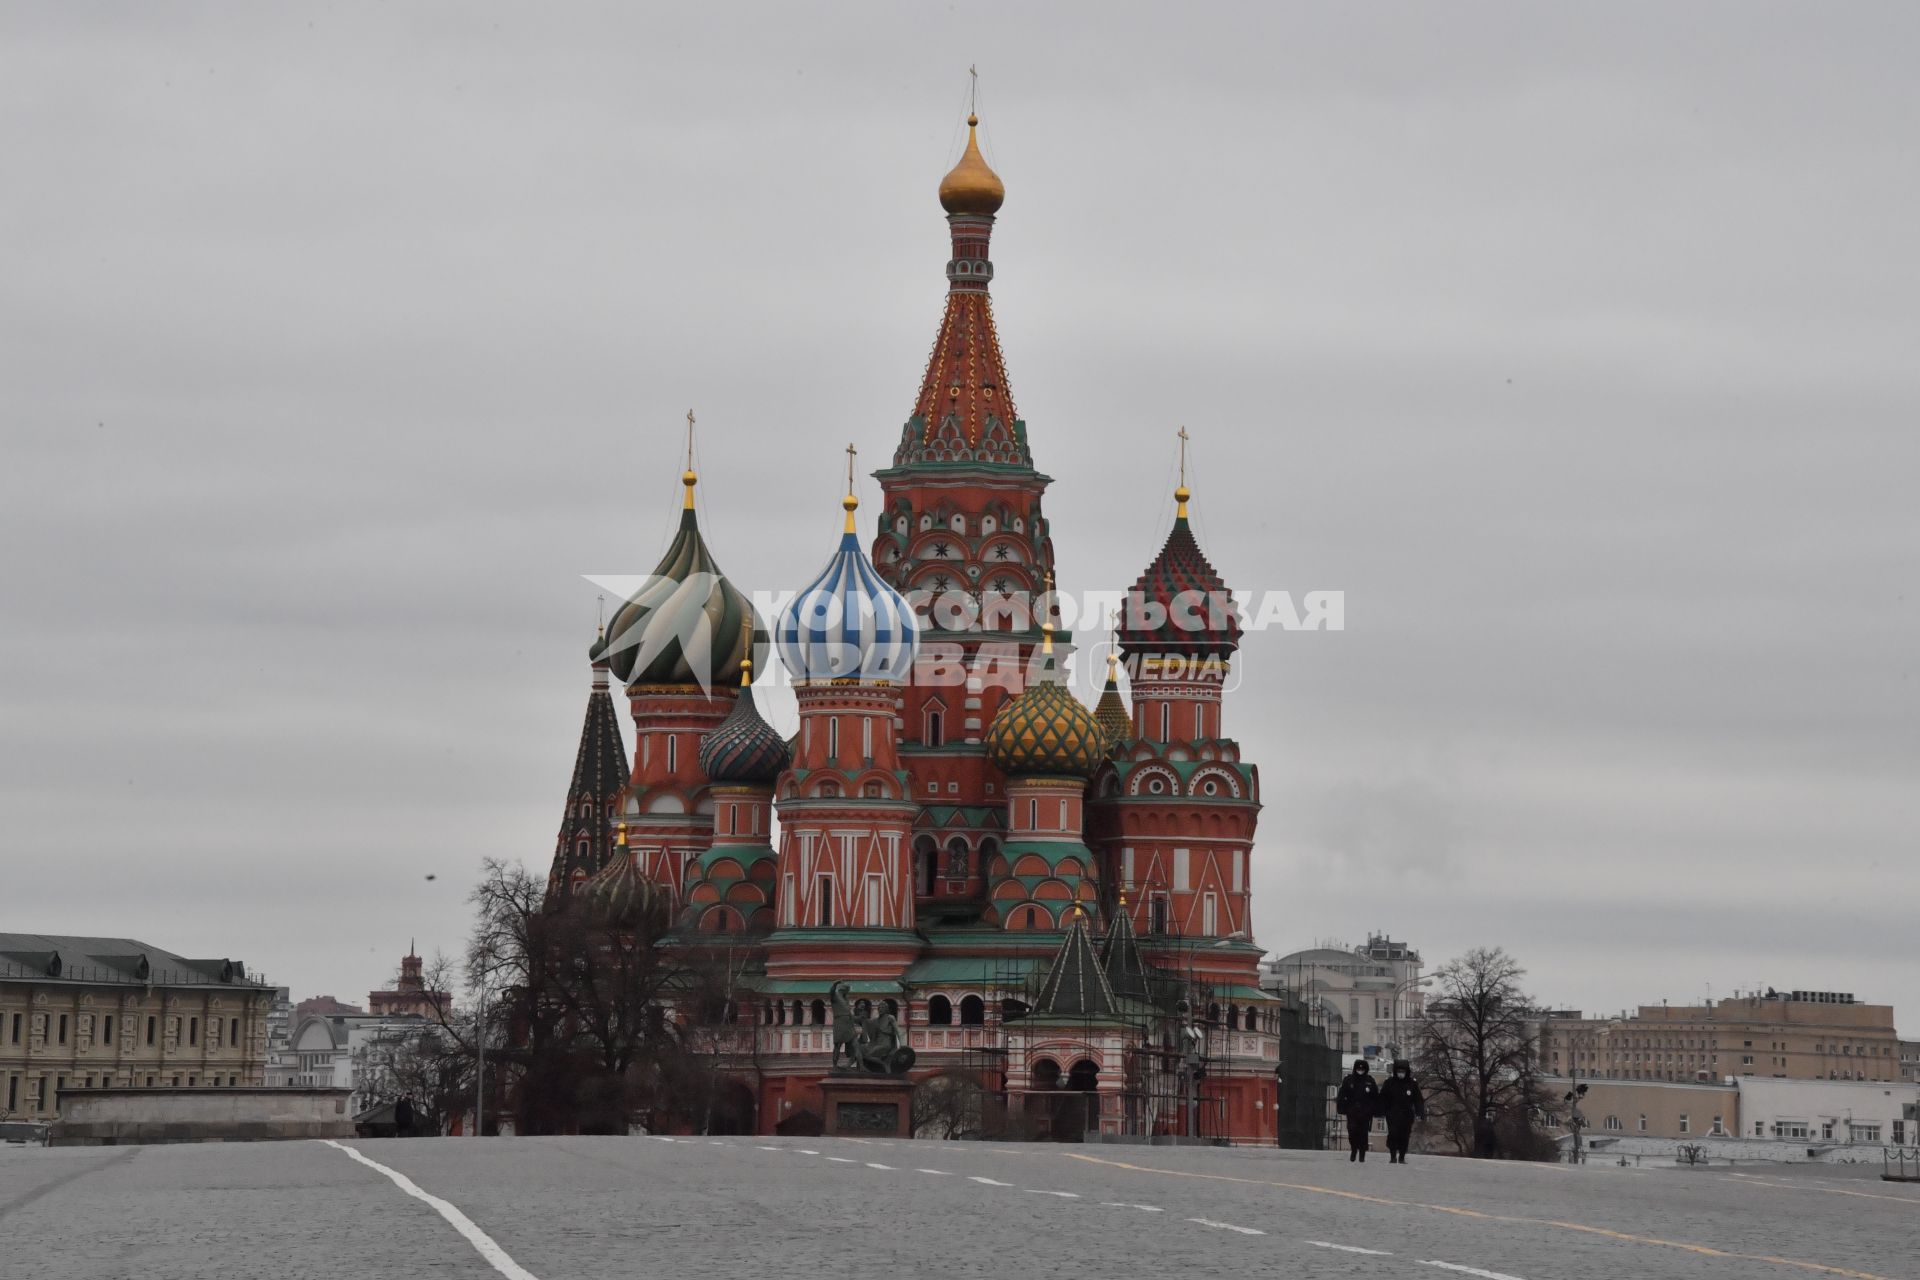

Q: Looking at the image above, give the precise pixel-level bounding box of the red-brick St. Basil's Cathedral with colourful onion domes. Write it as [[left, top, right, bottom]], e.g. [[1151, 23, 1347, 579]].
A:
[[549, 115, 1281, 1142]]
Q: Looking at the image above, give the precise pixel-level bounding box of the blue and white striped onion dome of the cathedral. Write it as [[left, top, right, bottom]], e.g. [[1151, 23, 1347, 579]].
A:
[[774, 497, 918, 685]]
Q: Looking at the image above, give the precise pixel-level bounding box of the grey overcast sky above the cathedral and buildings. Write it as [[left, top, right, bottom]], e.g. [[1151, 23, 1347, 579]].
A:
[[0, 4, 1920, 1032]]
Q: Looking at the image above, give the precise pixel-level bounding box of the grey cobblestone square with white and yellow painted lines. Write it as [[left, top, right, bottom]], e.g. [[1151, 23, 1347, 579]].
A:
[[0, 1138, 1920, 1280]]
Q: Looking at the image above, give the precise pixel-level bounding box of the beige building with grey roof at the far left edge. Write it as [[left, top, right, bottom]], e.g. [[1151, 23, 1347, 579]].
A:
[[0, 933, 275, 1121]]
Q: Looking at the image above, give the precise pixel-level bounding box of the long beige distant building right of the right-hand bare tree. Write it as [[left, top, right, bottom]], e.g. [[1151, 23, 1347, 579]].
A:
[[1540, 990, 1901, 1082]]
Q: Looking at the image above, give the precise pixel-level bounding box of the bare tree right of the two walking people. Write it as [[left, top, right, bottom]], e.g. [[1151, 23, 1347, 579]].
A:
[[1415, 946, 1553, 1159]]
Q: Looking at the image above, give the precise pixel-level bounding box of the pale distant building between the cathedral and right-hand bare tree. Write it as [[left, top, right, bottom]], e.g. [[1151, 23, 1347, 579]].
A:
[[1260, 935, 1425, 1059]]
